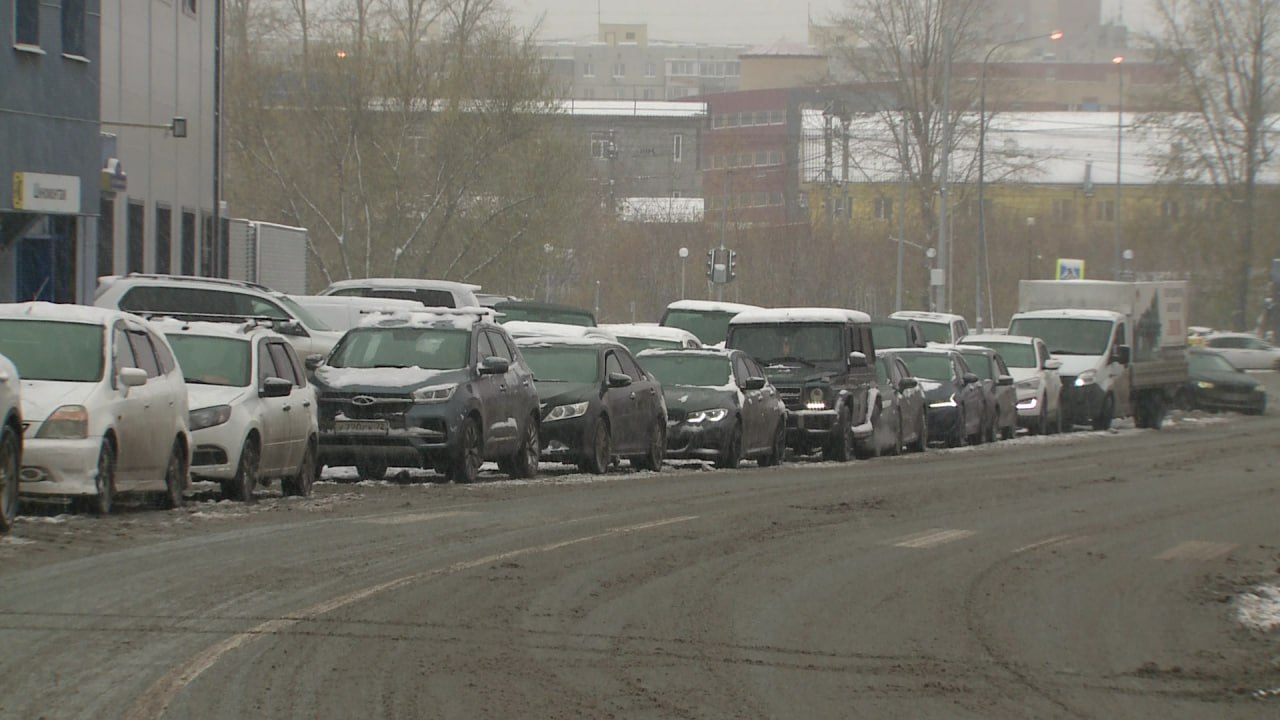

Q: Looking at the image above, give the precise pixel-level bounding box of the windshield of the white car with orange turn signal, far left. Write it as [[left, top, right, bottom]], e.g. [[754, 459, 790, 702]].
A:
[[0, 320, 105, 383]]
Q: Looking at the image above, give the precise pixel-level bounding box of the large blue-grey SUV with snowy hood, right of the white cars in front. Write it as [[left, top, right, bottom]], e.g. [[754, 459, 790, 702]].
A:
[[308, 309, 541, 483]]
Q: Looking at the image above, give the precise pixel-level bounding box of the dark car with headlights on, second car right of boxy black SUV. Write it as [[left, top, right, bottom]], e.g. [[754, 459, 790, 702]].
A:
[[890, 347, 984, 447]]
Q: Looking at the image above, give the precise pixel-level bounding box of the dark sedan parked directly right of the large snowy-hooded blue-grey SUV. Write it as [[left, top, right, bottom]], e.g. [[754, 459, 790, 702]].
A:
[[516, 337, 667, 474]]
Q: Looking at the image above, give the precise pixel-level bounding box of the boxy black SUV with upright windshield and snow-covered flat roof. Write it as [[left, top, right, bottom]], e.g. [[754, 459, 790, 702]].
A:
[[726, 307, 879, 461]]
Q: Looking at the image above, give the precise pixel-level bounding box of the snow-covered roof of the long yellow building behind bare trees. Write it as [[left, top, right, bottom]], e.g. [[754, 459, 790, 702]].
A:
[[800, 110, 1280, 187]]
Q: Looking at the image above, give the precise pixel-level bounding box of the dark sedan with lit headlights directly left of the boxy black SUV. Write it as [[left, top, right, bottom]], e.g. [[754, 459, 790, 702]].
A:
[[637, 348, 787, 468]]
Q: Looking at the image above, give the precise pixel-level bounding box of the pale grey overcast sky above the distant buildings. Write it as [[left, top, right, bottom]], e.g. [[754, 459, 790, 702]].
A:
[[506, 0, 1149, 45]]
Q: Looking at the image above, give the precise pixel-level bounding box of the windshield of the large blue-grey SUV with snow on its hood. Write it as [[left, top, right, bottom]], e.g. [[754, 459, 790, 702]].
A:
[[328, 327, 471, 370]]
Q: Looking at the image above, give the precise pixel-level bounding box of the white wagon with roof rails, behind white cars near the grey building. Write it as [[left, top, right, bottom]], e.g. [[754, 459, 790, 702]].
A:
[[93, 273, 342, 357]]
